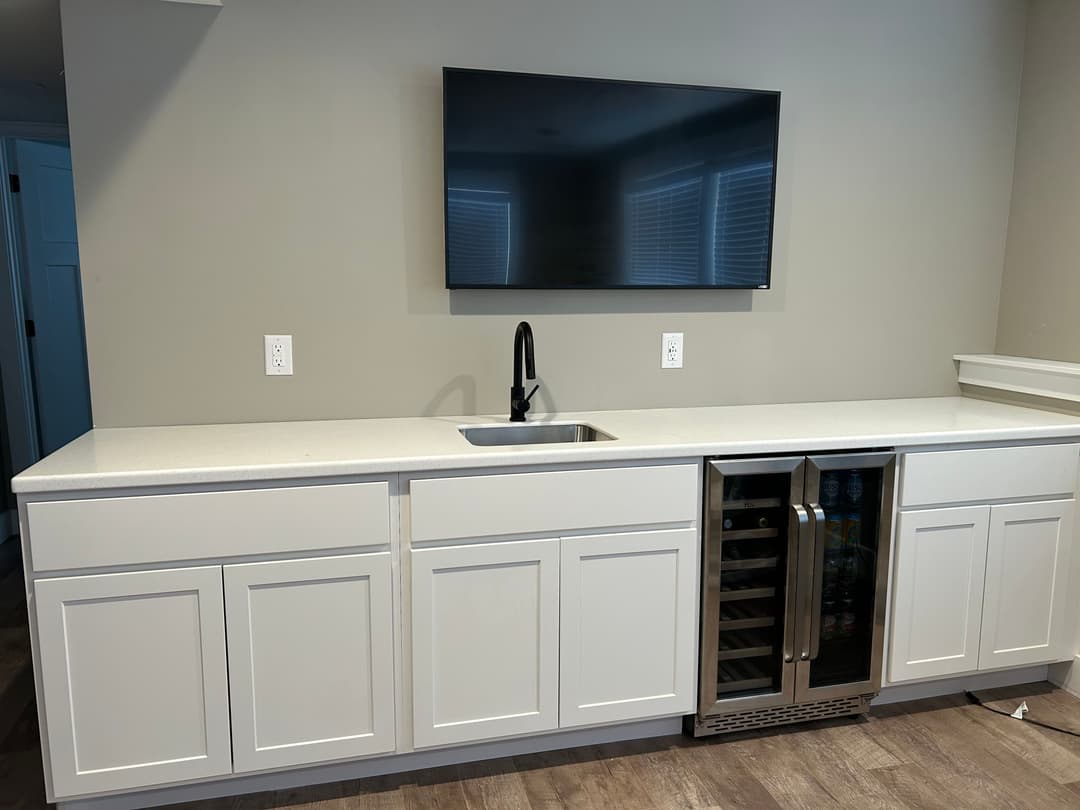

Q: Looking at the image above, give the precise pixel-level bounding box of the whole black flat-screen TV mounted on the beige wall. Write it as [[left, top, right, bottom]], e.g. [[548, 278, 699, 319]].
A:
[[443, 68, 780, 289]]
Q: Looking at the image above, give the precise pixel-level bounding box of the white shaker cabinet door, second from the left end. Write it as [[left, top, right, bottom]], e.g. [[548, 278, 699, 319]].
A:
[[224, 552, 395, 772]]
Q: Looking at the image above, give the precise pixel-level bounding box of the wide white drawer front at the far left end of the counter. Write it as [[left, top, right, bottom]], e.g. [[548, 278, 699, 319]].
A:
[[26, 481, 390, 571]]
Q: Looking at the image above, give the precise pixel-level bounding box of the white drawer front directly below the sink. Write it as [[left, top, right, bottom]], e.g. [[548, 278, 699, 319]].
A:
[[409, 464, 701, 542]]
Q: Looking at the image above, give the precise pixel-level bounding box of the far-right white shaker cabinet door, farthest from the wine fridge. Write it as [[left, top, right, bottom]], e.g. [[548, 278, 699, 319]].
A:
[[978, 500, 1076, 670]]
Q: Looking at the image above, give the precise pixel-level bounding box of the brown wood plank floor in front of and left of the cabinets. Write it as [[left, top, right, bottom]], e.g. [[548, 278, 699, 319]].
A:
[[0, 544, 1080, 810]]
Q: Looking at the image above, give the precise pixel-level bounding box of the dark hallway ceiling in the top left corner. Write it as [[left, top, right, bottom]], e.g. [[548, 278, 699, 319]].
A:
[[0, 0, 64, 94]]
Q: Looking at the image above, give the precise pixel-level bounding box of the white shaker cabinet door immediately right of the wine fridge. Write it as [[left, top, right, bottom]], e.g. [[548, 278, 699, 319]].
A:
[[889, 507, 990, 683]]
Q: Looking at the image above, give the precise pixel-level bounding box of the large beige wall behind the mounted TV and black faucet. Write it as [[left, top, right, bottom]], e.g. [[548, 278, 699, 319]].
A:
[[63, 0, 1025, 426]]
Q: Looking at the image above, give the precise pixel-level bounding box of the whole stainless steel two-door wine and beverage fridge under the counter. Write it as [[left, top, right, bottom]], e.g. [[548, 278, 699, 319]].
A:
[[687, 451, 895, 737]]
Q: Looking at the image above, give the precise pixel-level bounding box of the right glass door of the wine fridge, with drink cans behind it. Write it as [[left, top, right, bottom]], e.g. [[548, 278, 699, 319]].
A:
[[796, 453, 895, 701]]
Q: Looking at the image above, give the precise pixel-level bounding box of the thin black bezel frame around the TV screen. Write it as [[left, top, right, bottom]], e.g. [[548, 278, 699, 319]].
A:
[[443, 65, 780, 292]]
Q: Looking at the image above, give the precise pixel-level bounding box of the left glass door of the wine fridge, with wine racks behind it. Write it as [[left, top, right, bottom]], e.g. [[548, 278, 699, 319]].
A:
[[699, 458, 810, 716]]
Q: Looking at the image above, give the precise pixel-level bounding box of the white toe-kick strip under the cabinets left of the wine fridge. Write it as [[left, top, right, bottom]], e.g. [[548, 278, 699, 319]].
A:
[[56, 717, 683, 810]]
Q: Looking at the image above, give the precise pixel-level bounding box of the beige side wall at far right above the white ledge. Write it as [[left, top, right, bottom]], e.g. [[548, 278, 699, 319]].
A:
[[997, 0, 1080, 362]]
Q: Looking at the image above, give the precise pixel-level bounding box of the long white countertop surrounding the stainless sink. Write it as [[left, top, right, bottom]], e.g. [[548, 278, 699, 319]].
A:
[[13, 396, 1080, 492]]
